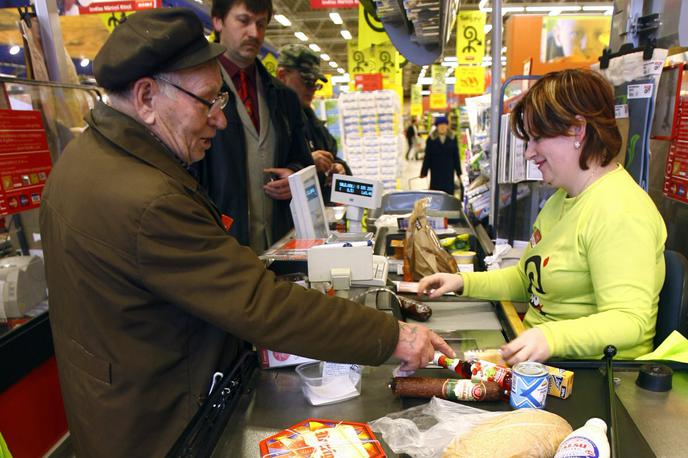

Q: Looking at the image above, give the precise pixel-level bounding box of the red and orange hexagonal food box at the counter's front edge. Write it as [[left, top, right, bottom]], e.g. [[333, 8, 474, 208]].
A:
[[259, 418, 385, 458]]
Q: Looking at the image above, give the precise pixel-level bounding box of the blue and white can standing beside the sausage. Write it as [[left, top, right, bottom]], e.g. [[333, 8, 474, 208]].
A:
[[509, 361, 549, 409]]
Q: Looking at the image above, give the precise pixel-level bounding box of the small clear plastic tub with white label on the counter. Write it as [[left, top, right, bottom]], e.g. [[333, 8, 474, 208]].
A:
[[296, 362, 361, 406]]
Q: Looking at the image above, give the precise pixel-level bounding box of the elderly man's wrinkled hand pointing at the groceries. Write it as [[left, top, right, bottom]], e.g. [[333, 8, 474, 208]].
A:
[[394, 321, 456, 371]]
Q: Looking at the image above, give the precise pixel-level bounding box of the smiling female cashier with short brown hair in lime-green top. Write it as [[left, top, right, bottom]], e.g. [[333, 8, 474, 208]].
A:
[[419, 70, 666, 364]]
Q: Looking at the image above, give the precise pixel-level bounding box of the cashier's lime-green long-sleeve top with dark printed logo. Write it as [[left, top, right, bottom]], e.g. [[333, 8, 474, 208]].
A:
[[461, 167, 666, 358]]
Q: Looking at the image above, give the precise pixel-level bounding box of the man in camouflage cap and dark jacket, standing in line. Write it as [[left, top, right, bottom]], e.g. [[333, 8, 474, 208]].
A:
[[277, 44, 351, 204]]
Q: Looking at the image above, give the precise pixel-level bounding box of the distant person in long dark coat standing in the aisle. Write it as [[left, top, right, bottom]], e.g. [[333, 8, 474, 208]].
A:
[[420, 116, 463, 200]]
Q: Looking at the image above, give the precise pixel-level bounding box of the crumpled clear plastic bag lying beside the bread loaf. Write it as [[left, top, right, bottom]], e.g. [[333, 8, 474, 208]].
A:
[[370, 398, 504, 458]]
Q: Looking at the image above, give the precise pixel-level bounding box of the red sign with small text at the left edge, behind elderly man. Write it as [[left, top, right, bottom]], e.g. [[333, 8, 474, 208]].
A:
[[0, 110, 52, 216]]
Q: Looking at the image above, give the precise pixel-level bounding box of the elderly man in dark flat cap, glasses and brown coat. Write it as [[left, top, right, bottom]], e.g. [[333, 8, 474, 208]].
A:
[[40, 8, 453, 457]]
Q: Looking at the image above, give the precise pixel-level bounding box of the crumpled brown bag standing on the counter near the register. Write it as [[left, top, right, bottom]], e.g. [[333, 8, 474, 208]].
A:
[[404, 198, 459, 281]]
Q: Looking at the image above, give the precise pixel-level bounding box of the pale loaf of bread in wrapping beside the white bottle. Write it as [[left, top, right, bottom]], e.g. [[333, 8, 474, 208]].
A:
[[442, 409, 572, 458]]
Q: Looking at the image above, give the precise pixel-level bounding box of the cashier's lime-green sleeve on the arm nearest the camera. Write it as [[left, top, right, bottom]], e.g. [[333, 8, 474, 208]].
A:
[[537, 211, 664, 358]]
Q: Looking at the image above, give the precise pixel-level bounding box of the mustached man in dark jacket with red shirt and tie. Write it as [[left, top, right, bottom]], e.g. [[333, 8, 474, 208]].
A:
[[194, 0, 313, 254]]
